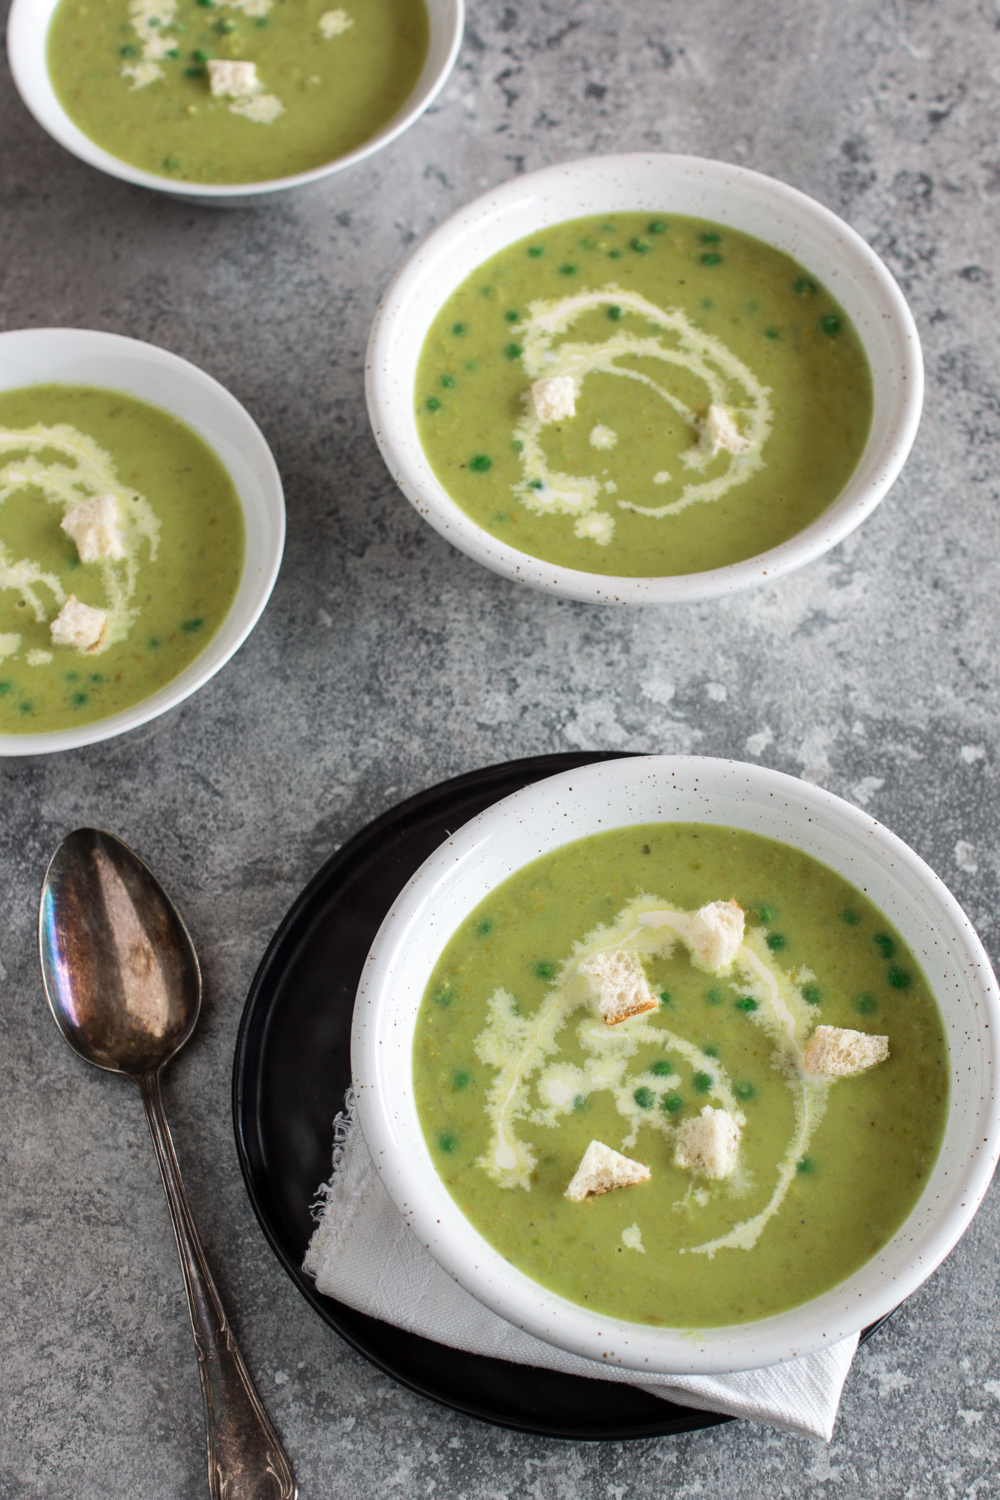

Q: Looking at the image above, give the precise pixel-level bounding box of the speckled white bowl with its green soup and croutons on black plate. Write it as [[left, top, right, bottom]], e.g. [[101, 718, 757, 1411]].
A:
[[352, 756, 1000, 1374]]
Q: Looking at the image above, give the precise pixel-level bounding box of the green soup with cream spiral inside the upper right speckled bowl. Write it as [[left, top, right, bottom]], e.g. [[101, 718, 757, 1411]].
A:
[[415, 213, 873, 578]]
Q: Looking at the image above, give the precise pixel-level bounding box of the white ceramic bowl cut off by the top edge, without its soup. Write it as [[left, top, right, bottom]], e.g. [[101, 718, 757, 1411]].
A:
[[7, 0, 465, 209]]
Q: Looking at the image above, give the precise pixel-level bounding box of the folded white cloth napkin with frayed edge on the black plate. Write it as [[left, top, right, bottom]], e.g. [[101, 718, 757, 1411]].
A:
[[304, 1095, 858, 1443]]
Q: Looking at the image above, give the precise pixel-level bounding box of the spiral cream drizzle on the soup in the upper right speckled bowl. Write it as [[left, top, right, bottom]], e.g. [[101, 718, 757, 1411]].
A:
[[511, 285, 771, 540]]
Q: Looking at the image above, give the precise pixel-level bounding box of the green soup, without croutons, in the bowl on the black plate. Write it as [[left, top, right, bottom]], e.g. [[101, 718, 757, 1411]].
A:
[[414, 824, 948, 1328]]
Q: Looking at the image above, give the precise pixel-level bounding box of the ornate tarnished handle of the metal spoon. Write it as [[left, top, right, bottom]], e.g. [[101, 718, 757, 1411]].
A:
[[138, 1073, 298, 1500]]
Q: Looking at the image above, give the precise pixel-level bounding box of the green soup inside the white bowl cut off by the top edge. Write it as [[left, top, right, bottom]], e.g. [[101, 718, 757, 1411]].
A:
[[48, 0, 430, 183]]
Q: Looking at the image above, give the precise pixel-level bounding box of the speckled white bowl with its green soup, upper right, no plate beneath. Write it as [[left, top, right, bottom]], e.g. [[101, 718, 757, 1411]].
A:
[[367, 155, 924, 605]]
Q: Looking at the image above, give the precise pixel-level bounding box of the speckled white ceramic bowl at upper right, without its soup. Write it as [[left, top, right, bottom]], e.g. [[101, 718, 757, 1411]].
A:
[[366, 155, 924, 605]]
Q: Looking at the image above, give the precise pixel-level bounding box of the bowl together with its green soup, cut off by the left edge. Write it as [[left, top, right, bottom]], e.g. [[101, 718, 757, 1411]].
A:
[[0, 329, 285, 755]]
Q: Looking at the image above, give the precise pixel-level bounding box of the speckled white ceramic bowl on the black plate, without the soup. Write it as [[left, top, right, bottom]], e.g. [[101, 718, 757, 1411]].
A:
[[352, 756, 1000, 1374]]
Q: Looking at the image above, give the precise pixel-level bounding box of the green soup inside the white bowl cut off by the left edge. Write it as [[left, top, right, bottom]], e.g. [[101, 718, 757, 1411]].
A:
[[0, 386, 244, 734]]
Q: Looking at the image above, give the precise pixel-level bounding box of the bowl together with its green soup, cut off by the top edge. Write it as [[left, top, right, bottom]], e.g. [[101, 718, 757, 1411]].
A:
[[7, 0, 463, 207]]
